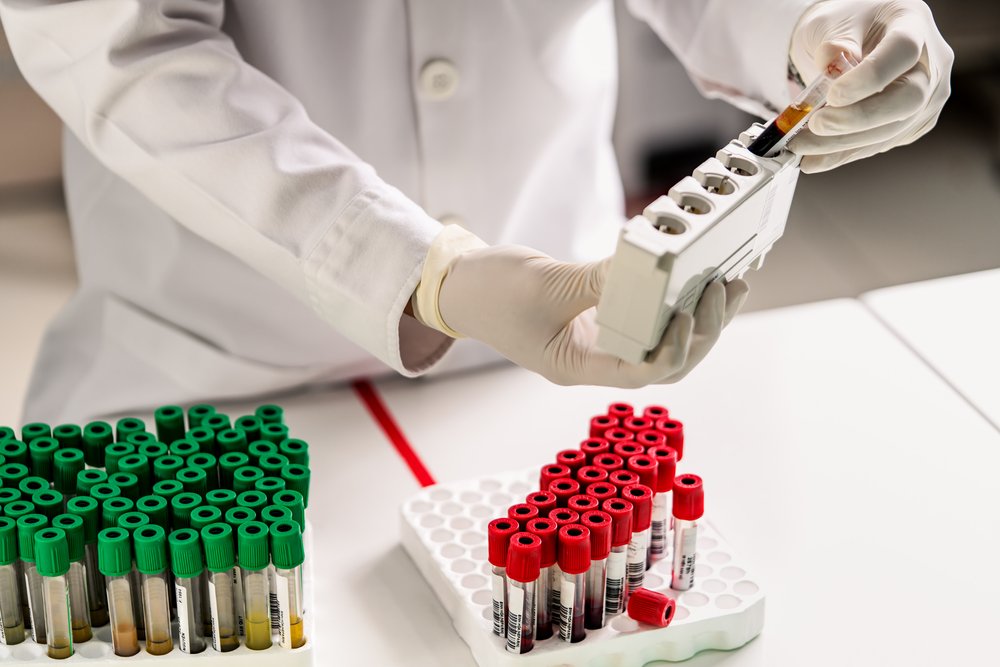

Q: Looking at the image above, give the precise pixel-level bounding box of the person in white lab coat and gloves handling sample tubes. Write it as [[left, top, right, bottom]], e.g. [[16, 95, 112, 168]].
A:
[[0, 0, 952, 422]]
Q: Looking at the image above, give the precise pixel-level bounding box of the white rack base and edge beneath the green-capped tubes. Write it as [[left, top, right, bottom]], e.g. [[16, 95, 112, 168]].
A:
[[0, 522, 316, 667]]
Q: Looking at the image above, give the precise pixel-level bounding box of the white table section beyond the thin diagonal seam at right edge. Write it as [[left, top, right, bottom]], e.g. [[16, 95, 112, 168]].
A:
[[862, 269, 1000, 429]]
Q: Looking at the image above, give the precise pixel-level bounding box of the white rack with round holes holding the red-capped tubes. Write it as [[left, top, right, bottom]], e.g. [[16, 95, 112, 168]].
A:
[[401, 469, 764, 667]]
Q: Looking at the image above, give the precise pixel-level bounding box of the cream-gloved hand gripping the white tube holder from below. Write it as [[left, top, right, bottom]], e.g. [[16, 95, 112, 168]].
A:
[[414, 226, 749, 387]]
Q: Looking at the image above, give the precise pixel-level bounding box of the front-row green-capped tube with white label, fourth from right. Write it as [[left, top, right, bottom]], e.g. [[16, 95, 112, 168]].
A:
[[169, 528, 206, 654]]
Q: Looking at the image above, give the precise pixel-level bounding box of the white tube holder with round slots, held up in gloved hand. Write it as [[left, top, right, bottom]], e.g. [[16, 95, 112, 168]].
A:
[[597, 123, 799, 363]]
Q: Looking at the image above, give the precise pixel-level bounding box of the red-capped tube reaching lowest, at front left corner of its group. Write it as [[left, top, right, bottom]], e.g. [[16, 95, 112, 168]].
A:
[[507, 532, 542, 653]]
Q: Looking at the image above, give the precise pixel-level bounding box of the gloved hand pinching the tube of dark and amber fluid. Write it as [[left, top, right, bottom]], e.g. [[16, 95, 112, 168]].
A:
[[790, 0, 955, 172]]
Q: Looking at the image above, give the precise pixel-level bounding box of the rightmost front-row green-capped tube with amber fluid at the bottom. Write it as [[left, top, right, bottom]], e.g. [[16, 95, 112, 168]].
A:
[[270, 521, 306, 648]]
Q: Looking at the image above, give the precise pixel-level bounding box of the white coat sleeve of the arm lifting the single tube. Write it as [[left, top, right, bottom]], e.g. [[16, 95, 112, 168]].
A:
[[627, 0, 817, 117]]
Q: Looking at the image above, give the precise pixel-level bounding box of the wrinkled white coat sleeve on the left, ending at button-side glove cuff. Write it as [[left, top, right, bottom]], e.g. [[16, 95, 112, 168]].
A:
[[0, 0, 450, 375]]
